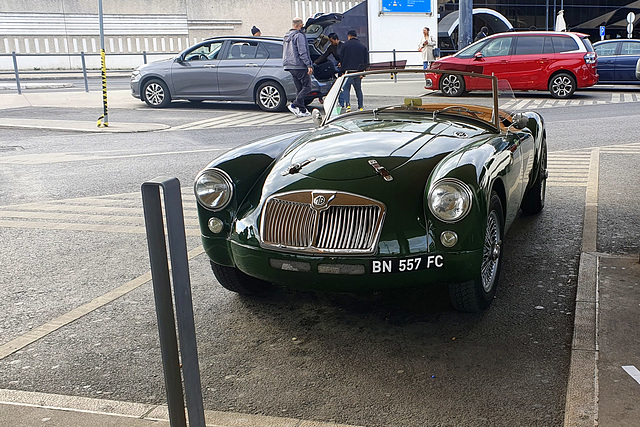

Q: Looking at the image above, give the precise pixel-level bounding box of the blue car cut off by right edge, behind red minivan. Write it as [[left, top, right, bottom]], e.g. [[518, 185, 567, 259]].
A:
[[593, 39, 640, 84]]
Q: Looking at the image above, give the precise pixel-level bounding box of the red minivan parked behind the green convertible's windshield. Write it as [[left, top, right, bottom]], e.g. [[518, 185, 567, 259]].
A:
[[425, 31, 598, 98]]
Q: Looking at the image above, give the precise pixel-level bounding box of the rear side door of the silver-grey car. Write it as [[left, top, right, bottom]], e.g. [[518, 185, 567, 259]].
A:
[[218, 40, 269, 100]]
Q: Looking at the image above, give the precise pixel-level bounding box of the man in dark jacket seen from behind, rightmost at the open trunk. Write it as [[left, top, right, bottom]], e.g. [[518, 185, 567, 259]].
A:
[[338, 30, 369, 111]]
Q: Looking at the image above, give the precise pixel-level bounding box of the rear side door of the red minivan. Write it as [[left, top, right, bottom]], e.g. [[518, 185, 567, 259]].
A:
[[509, 36, 553, 90]]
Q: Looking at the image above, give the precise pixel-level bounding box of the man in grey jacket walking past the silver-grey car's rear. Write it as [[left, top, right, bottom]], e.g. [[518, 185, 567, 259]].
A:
[[282, 18, 313, 117]]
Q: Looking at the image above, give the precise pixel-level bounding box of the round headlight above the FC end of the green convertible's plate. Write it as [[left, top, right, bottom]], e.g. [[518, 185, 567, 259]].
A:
[[427, 179, 472, 222]]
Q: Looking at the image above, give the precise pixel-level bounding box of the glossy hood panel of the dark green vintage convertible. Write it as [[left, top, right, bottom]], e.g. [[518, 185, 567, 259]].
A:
[[273, 118, 486, 181]]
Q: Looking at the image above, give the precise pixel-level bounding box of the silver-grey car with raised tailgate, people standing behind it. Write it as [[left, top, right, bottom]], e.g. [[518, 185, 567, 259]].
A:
[[130, 13, 342, 111]]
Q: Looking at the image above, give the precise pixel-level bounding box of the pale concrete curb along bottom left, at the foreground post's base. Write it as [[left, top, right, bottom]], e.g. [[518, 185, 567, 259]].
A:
[[0, 389, 354, 427]]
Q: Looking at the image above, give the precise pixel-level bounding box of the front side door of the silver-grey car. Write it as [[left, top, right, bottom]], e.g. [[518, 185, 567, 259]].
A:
[[171, 40, 224, 99]]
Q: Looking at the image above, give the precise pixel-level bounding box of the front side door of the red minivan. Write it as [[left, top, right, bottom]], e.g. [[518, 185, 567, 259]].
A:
[[469, 36, 514, 90]]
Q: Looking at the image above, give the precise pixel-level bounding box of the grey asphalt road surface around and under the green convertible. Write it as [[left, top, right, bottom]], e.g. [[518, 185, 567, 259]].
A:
[[0, 90, 640, 426]]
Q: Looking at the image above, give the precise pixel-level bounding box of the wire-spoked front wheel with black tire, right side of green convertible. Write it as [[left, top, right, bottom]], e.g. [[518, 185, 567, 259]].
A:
[[449, 191, 504, 313]]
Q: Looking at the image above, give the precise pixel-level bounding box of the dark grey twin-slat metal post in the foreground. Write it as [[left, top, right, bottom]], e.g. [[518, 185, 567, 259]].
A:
[[142, 177, 205, 427]]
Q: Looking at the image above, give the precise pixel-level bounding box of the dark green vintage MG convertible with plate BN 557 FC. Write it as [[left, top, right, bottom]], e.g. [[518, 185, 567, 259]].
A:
[[194, 70, 547, 312]]
